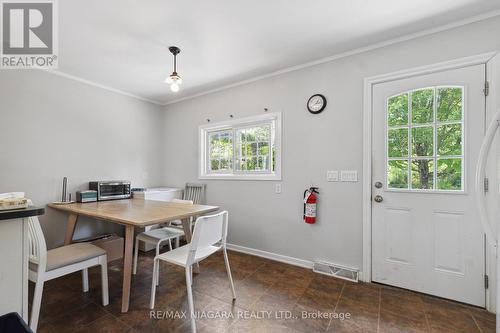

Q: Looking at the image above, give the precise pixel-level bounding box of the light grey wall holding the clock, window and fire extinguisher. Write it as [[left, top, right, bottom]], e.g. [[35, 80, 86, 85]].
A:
[[163, 17, 500, 268]]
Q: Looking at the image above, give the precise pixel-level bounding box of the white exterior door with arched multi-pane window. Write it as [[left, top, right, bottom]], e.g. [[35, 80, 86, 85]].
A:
[[372, 65, 485, 306]]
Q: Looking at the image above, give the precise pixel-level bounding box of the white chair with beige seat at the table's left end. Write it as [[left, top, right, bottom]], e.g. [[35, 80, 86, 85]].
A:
[[28, 216, 109, 332]]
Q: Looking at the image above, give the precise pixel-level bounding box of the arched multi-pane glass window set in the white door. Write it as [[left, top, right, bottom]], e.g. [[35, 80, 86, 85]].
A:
[[386, 86, 464, 191]]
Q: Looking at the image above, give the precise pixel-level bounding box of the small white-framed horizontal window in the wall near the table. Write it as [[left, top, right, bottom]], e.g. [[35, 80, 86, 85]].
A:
[[200, 113, 281, 180]]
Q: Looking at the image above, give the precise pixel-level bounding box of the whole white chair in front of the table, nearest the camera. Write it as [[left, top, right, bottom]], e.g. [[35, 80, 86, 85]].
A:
[[150, 211, 236, 332]]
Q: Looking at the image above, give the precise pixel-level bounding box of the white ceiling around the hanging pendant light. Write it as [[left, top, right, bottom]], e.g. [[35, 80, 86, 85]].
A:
[[58, 0, 500, 103]]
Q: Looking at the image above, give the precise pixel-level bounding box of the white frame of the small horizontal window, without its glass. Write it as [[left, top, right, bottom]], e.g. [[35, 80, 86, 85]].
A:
[[198, 112, 282, 180]]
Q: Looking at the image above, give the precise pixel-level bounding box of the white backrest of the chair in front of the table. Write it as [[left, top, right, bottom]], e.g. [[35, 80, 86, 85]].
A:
[[187, 211, 229, 265]]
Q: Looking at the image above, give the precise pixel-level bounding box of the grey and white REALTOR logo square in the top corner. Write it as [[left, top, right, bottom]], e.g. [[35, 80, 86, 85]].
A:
[[0, 0, 57, 69]]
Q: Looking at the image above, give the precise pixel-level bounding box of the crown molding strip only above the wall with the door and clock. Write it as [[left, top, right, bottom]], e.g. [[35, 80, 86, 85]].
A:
[[163, 10, 500, 106]]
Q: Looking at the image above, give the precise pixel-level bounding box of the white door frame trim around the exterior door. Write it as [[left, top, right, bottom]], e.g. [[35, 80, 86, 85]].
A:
[[361, 51, 498, 310]]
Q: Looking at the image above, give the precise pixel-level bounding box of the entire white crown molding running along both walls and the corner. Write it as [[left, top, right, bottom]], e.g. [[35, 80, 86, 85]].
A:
[[35, 10, 500, 106]]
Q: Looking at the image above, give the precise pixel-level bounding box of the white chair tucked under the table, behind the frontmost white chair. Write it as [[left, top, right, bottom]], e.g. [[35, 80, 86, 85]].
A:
[[133, 199, 193, 275]]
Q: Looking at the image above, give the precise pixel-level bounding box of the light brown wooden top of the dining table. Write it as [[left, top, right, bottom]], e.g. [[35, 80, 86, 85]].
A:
[[48, 199, 219, 227]]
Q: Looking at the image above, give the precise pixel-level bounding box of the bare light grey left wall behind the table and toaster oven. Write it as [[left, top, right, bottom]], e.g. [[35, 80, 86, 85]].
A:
[[0, 70, 163, 247]]
